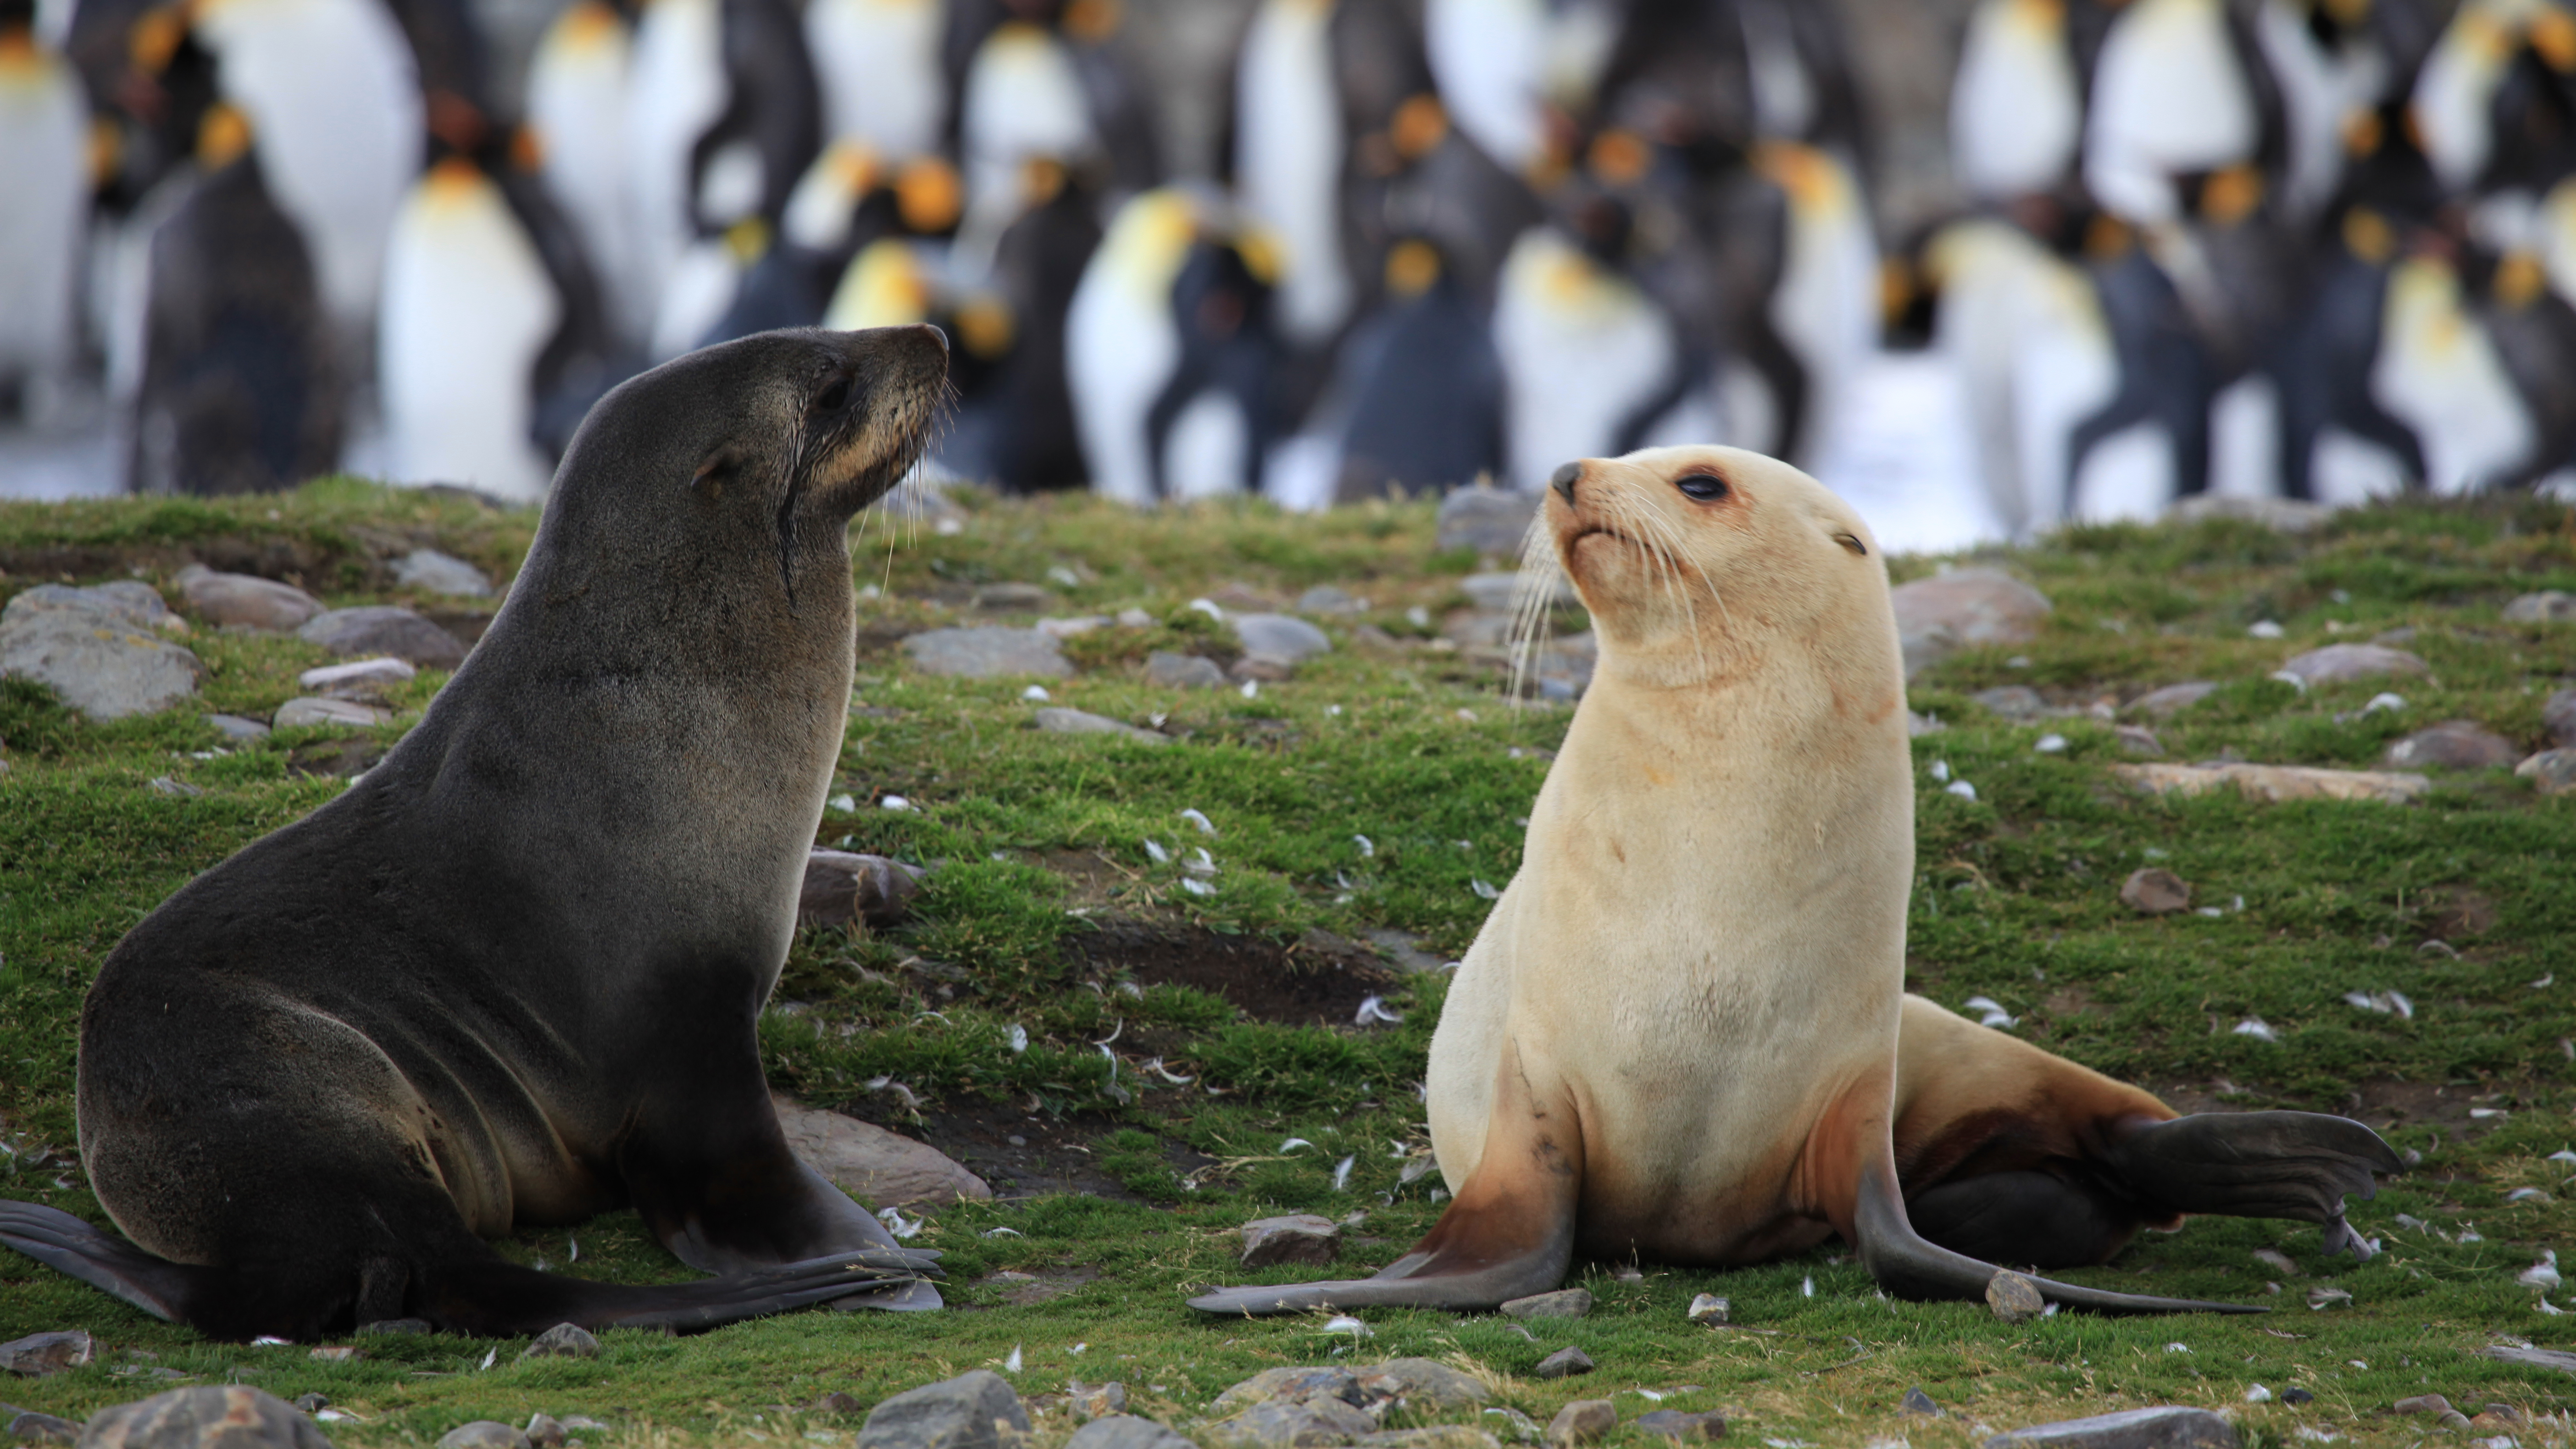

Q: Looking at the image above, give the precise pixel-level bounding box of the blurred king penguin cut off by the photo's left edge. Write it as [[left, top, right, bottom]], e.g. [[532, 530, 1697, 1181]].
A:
[[0, 0, 90, 418]]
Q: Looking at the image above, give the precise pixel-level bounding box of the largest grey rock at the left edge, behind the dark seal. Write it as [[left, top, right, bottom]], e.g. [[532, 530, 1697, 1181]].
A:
[[0, 580, 206, 719]]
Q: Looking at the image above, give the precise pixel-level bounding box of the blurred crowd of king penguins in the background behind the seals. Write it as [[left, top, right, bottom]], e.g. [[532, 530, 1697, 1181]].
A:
[[0, 0, 2576, 531]]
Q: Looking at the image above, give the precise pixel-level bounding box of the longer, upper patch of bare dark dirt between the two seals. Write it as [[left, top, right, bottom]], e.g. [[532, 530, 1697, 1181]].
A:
[[1066, 921, 1396, 1026]]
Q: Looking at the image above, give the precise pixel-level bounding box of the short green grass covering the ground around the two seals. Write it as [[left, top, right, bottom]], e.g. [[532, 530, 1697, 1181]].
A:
[[0, 482, 2576, 1449]]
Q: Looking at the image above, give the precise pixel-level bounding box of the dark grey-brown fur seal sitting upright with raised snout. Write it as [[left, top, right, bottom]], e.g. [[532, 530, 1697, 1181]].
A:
[[0, 328, 948, 1338]]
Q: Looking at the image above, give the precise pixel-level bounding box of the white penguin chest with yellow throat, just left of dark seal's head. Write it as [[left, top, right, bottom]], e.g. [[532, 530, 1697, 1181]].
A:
[[379, 162, 561, 503]]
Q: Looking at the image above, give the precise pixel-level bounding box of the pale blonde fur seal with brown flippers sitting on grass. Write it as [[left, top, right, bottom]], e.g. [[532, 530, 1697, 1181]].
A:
[[1193, 449, 2398, 1312]]
